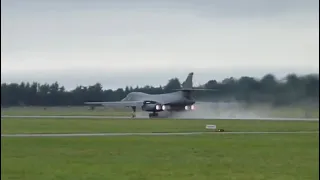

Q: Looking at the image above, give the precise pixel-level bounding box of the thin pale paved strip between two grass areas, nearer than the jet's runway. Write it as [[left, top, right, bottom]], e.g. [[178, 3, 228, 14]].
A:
[[1, 131, 319, 137]]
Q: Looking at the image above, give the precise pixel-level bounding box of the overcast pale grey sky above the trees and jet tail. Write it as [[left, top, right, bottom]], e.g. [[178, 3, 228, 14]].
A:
[[1, 0, 319, 88]]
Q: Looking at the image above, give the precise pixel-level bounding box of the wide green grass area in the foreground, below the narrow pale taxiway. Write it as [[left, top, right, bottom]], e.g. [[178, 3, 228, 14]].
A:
[[1, 134, 319, 180]]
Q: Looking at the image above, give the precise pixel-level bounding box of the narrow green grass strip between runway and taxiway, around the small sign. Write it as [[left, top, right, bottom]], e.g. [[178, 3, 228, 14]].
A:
[[1, 118, 319, 133]]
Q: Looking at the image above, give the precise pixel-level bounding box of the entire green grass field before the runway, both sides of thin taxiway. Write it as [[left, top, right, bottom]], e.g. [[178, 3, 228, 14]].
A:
[[1, 118, 319, 180]]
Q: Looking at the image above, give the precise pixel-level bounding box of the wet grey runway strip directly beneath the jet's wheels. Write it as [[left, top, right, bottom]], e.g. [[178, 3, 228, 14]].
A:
[[1, 115, 319, 121]]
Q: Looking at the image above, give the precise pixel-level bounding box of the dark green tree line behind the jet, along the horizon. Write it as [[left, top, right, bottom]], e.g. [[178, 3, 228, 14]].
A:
[[1, 74, 319, 107]]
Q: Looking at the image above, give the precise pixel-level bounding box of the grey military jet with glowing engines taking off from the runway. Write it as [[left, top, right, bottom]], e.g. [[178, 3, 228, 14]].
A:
[[85, 72, 212, 118]]
